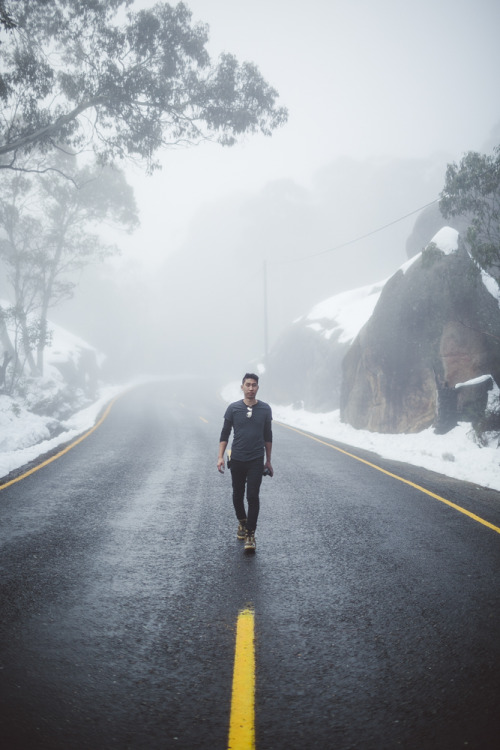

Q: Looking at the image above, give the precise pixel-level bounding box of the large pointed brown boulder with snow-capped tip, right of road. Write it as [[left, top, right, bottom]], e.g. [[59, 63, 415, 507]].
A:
[[340, 228, 500, 433]]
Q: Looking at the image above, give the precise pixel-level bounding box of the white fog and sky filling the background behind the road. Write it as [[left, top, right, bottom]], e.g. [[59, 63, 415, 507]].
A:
[[52, 0, 500, 380]]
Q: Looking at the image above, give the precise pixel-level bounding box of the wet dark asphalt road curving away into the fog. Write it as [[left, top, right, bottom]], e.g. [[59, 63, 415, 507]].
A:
[[0, 379, 500, 750]]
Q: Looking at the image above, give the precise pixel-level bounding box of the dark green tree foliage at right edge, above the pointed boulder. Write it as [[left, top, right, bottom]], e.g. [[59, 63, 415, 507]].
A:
[[440, 146, 500, 283]]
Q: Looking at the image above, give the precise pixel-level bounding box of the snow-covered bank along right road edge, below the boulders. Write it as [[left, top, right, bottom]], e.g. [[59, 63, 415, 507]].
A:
[[221, 383, 500, 491]]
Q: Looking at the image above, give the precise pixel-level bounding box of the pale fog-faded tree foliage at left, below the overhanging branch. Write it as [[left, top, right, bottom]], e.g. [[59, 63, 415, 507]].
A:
[[0, 157, 138, 382]]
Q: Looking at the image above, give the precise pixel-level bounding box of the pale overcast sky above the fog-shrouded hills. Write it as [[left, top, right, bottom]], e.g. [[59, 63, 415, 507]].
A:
[[120, 0, 500, 268]]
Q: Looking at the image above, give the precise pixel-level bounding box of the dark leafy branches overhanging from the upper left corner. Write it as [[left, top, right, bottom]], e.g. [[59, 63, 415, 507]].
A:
[[0, 0, 287, 170]]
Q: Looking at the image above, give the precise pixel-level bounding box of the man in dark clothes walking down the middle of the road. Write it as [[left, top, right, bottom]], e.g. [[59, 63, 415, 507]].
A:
[[217, 372, 274, 552]]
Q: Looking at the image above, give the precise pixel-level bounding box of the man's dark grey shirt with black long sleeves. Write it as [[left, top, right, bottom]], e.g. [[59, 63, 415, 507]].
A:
[[220, 399, 273, 461]]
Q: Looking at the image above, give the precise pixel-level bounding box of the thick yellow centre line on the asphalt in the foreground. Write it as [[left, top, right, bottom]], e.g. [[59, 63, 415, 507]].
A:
[[228, 609, 255, 750]]
